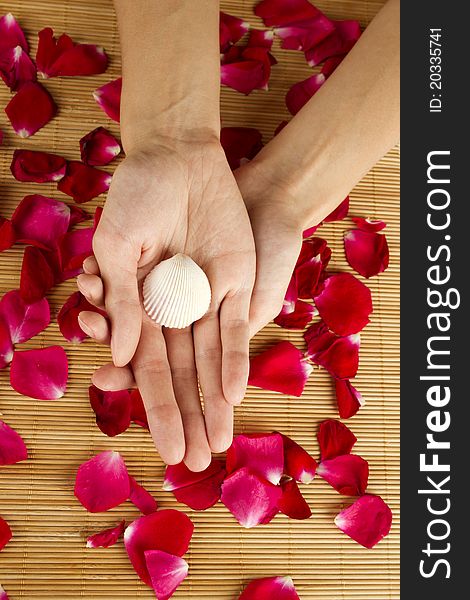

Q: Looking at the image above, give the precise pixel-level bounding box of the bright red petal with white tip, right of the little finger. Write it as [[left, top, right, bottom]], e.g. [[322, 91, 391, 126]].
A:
[[248, 342, 313, 397]]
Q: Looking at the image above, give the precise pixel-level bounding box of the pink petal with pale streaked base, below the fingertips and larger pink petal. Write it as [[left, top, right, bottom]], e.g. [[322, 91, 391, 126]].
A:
[[220, 467, 282, 529]]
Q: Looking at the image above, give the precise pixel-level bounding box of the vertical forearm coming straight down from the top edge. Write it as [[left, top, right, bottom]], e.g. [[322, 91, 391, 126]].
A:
[[114, 0, 220, 153]]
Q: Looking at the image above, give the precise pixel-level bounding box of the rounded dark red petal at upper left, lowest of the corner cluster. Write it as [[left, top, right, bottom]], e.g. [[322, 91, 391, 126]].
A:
[[5, 82, 57, 138]]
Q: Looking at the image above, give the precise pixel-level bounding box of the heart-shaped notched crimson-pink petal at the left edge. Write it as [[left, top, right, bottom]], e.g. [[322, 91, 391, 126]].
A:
[[0, 290, 51, 344]]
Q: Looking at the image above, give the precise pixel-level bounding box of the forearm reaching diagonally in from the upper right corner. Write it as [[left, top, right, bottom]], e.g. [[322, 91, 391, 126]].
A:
[[248, 0, 399, 226]]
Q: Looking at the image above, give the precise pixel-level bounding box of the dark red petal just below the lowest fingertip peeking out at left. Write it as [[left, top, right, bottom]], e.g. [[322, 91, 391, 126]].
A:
[[88, 385, 131, 437]]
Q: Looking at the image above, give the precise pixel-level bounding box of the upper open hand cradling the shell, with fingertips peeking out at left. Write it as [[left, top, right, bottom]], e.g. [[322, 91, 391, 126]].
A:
[[78, 139, 255, 470]]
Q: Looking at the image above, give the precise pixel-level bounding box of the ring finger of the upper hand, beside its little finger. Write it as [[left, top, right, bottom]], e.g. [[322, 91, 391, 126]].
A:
[[193, 308, 233, 452]]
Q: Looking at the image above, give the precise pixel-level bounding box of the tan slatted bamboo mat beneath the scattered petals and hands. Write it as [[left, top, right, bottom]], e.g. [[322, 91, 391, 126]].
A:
[[0, 0, 399, 600]]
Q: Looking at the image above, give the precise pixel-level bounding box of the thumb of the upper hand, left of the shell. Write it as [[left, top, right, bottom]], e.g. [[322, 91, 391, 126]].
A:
[[92, 230, 142, 367]]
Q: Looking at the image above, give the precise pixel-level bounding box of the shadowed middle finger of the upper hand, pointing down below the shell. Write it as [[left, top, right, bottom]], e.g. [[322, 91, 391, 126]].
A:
[[163, 327, 211, 471]]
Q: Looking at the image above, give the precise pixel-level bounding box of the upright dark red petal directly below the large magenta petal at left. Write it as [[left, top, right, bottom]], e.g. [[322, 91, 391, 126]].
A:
[[20, 246, 55, 304]]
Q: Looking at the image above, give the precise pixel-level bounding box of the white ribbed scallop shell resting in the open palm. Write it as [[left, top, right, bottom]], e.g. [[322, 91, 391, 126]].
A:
[[143, 254, 211, 329]]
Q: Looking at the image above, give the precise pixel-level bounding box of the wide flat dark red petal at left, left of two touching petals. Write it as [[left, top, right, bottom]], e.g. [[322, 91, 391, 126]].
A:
[[10, 150, 67, 183]]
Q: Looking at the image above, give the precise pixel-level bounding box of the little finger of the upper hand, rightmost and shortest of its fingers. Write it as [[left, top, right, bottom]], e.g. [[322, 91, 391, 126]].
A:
[[220, 290, 251, 404]]
